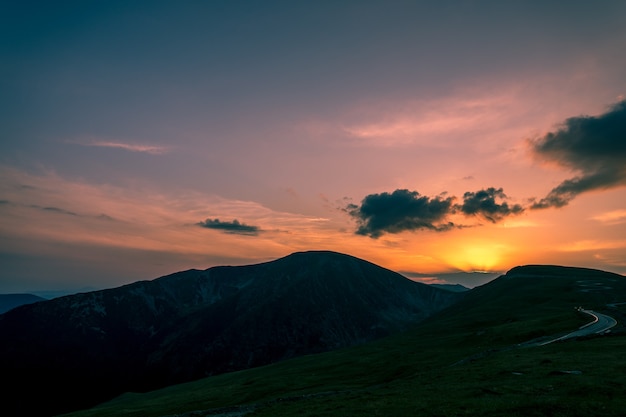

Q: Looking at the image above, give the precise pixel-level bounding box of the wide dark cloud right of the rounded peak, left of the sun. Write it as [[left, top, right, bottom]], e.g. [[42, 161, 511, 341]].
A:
[[346, 189, 454, 238]]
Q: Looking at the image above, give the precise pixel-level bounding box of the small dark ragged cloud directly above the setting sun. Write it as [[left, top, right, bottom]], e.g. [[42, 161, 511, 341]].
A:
[[456, 187, 524, 223]]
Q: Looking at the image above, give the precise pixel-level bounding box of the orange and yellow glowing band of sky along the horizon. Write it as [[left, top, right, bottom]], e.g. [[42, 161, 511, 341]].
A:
[[0, 162, 626, 292]]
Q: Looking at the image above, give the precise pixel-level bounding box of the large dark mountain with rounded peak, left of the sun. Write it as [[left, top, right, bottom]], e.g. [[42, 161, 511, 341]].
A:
[[0, 252, 461, 415]]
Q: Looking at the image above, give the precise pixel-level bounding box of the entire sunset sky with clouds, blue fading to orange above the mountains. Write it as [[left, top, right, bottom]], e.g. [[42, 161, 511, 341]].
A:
[[0, 0, 626, 293]]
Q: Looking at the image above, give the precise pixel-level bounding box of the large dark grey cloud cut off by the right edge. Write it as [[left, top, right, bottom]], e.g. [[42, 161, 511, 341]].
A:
[[531, 101, 626, 209]]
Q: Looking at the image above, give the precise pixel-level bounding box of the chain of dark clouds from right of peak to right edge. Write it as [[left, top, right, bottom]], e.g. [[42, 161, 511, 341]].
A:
[[344, 100, 626, 238]]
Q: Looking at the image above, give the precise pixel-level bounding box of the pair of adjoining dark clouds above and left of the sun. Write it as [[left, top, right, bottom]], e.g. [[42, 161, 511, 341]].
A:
[[345, 187, 524, 239]]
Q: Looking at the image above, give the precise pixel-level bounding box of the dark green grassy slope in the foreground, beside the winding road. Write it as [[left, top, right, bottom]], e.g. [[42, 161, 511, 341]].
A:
[[61, 267, 626, 416]]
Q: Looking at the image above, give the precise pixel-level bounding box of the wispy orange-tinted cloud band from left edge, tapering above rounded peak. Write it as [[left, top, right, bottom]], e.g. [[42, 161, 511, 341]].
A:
[[0, 166, 336, 259]]
